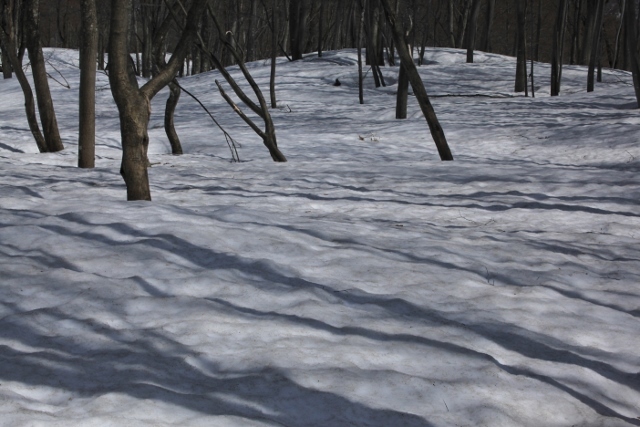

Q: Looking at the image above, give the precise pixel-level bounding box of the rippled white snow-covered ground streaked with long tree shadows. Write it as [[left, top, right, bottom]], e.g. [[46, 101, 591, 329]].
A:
[[0, 49, 640, 427]]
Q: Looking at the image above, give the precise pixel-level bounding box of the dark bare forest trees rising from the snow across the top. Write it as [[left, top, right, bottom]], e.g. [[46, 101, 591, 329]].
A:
[[0, 0, 640, 200]]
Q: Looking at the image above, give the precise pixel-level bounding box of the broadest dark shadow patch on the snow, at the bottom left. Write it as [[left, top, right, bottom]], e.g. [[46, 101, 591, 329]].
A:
[[0, 302, 432, 427]]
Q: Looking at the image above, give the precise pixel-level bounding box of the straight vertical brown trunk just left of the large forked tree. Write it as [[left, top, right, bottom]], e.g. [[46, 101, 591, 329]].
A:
[[78, 0, 98, 168]]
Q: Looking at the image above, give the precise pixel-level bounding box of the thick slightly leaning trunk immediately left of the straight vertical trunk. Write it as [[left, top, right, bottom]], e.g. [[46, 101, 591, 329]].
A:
[[25, 0, 64, 152]]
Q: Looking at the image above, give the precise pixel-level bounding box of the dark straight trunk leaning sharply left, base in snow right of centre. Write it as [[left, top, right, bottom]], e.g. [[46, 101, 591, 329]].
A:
[[380, 0, 453, 160]]
